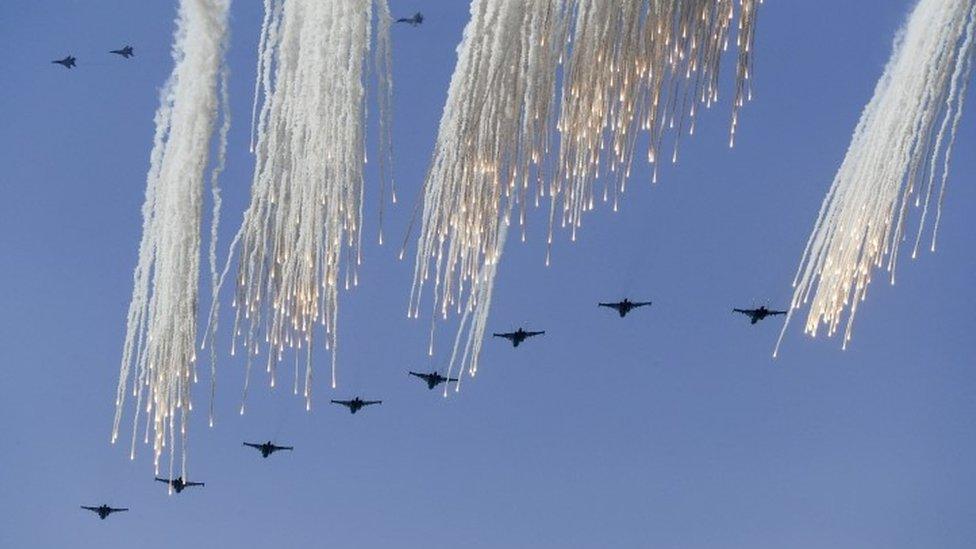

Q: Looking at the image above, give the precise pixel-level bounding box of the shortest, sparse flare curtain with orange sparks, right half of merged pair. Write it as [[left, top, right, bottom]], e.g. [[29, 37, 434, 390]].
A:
[[548, 0, 759, 253]]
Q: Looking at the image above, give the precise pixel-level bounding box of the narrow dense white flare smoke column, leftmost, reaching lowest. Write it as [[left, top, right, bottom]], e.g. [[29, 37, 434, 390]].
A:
[[112, 0, 230, 476]]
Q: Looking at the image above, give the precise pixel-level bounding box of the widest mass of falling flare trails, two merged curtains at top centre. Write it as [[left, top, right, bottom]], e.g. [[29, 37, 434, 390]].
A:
[[408, 0, 759, 384]]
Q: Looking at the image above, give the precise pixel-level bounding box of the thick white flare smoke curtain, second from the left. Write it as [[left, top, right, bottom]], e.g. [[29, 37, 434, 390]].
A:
[[214, 0, 392, 413]]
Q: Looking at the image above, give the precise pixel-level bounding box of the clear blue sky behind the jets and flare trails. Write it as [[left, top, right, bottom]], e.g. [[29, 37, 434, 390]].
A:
[[0, 0, 976, 548]]
